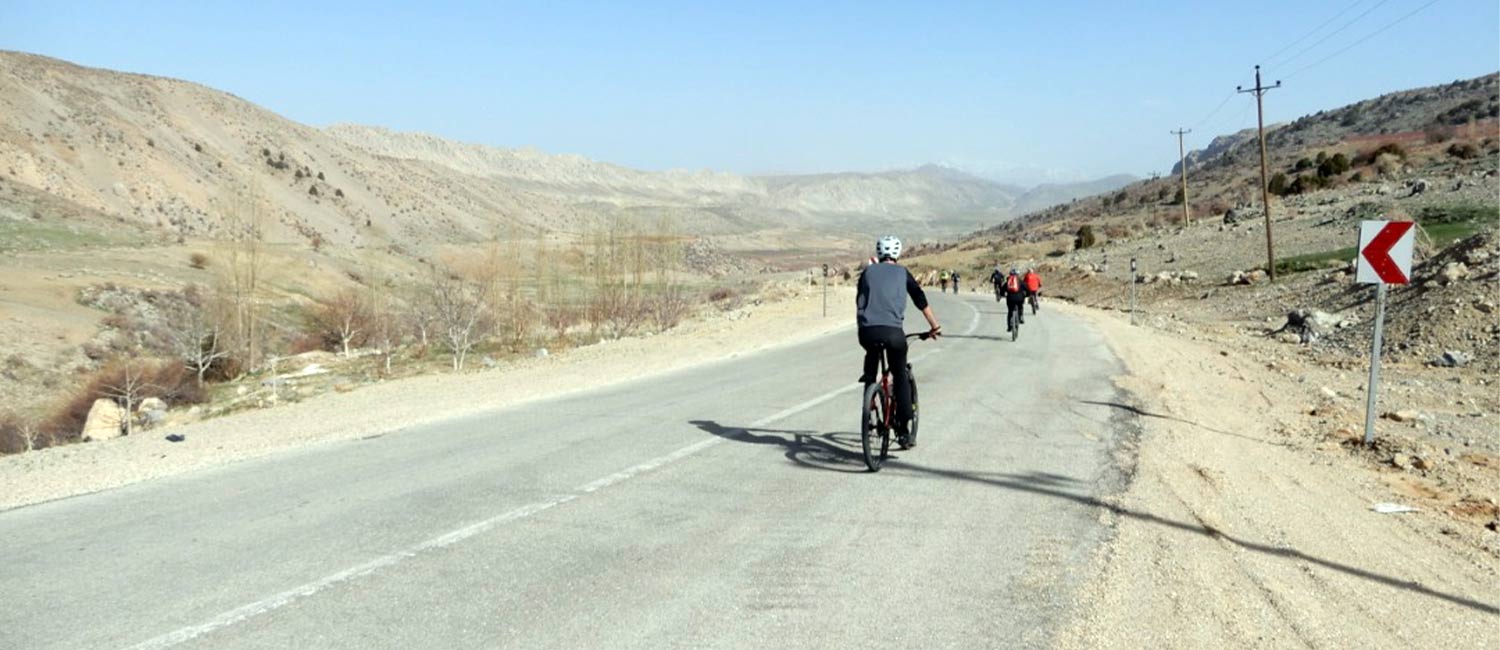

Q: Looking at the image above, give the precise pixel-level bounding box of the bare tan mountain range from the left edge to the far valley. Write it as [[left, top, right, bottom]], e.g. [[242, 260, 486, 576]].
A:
[[0, 53, 1133, 249]]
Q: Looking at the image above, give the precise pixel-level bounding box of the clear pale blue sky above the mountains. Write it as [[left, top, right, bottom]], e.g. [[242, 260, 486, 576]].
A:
[[0, 0, 1500, 182]]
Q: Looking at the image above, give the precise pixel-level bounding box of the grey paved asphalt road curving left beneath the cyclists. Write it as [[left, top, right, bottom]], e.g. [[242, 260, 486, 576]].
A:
[[0, 294, 1127, 648]]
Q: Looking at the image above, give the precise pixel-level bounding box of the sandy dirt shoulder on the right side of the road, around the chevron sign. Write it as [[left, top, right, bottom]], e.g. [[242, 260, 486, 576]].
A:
[[1053, 302, 1500, 648]]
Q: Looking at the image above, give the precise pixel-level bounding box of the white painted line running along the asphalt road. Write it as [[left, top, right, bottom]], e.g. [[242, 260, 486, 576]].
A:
[[129, 367, 876, 650]]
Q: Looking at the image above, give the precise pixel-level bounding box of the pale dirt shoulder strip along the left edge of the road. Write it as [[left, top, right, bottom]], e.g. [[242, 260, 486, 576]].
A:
[[0, 287, 854, 510]]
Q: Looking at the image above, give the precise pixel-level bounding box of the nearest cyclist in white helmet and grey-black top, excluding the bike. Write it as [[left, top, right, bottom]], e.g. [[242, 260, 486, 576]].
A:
[[855, 236, 942, 447]]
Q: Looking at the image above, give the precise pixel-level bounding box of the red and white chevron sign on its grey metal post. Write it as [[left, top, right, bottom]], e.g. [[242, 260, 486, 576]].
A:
[[1355, 221, 1416, 447]]
